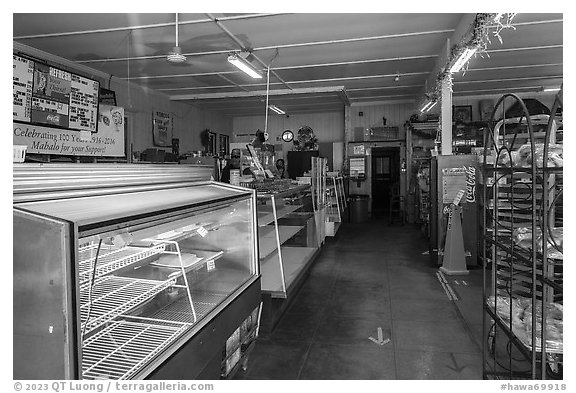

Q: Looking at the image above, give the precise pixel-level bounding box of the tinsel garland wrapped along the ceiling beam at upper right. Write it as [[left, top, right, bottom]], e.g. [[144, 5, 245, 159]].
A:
[[425, 13, 516, 100]]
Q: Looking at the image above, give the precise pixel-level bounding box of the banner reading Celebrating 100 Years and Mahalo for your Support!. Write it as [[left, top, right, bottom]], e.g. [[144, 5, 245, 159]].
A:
[[12, 105, 125, 157]]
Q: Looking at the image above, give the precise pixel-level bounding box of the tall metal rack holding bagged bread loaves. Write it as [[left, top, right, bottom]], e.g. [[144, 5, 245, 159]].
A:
[[482, 90, 563, 379]]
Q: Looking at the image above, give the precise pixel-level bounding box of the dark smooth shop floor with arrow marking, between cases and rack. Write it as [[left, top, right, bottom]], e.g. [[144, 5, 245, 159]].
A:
[[236, 220, 482, 380]]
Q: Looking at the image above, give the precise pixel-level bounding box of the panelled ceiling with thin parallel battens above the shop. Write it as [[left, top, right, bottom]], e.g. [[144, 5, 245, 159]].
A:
[[13, 13, 563, 116]]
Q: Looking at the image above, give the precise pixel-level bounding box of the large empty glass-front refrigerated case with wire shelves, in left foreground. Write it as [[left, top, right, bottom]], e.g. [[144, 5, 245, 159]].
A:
[[13, 164, 260, 379]]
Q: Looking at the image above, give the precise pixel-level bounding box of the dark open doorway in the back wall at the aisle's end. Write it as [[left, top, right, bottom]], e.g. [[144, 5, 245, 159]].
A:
[[372, 147, 400, 218]]
